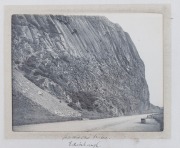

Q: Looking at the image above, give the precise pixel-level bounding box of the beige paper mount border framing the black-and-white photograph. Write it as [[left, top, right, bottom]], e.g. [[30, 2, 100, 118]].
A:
[[4, 4, 171, 139]]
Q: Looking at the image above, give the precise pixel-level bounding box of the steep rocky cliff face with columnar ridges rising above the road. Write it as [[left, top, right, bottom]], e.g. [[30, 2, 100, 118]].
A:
[[12, 15, 150, 116]]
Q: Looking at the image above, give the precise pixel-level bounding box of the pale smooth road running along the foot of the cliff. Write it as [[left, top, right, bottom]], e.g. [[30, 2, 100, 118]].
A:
[[13, 114, 160, 132]]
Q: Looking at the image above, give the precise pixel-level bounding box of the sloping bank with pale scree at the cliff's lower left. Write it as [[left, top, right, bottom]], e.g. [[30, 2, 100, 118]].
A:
[[13, 69, 81, 125]]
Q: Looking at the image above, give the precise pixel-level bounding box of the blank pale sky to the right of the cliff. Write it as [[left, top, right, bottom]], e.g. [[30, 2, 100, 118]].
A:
[[104, 13, 163, 107]]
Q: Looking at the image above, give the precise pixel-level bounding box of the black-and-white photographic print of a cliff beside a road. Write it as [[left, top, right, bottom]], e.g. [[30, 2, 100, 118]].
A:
[[11, 13, 164, 132]]
